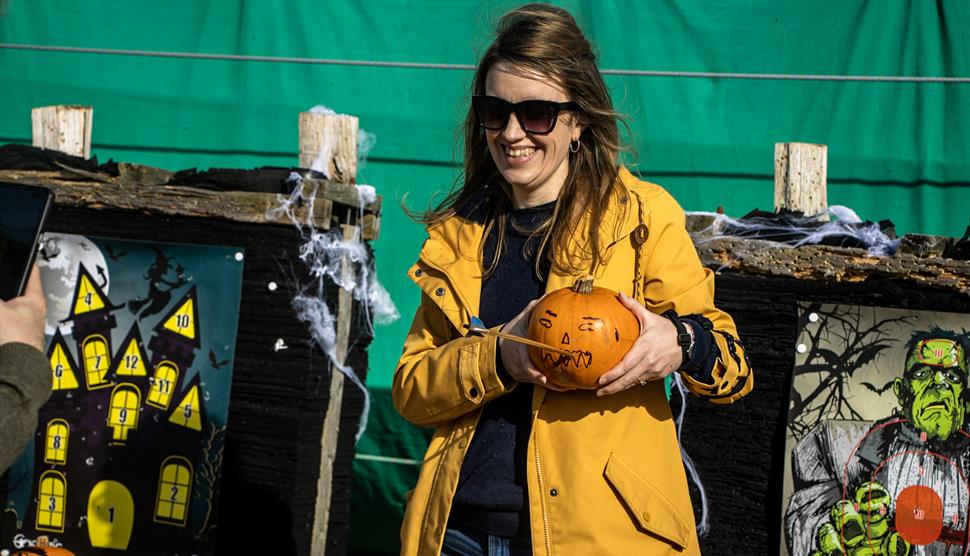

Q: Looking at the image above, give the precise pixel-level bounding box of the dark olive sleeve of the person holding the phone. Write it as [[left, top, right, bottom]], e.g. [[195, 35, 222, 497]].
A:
[[0, 343, 53, 473]]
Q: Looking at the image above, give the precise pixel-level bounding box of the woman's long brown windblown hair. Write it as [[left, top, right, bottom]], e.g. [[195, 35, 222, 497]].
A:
[[419, 4, 625, 275]]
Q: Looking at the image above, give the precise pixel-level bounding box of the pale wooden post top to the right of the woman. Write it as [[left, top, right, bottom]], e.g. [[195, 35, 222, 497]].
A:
[[775, 143, 828, 220]]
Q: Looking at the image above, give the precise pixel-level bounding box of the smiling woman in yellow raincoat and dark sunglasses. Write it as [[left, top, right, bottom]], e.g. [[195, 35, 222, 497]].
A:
[[393, 4, 752, 555]]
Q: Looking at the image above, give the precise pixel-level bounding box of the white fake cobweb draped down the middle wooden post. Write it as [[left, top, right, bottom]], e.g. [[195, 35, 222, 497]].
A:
[[267, 114, 400, 440]]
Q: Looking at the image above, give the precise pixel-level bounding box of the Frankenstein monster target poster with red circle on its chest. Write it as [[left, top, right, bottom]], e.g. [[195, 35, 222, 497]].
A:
[[782, 304, 970, 556]]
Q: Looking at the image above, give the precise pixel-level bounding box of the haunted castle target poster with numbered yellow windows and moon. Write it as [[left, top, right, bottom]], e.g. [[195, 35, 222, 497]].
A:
[[0, 234, 243, 555]]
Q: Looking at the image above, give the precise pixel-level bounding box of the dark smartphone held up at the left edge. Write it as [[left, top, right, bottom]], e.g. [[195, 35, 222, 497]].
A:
[[0, 182, 54, 301]]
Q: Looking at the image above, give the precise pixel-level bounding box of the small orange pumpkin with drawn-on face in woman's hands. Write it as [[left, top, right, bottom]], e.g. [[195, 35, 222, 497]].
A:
[[529, 276, 640, 388]]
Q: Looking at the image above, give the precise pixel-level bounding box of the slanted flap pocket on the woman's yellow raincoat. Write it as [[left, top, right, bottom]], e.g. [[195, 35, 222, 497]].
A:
[[604, 454, 691, 549]]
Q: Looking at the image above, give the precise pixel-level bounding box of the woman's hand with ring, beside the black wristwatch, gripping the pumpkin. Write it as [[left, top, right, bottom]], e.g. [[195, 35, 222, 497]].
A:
[[596, 293, 684, 396]]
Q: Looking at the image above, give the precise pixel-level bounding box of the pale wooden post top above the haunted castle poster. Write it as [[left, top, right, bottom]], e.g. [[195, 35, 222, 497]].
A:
[[30, 105, 94, 158]]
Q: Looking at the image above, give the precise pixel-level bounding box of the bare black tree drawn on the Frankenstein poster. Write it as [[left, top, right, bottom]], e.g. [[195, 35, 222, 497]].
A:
[[788, 303, 914, 441]]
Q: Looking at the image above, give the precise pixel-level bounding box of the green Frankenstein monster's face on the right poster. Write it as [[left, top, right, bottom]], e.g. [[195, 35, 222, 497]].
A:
[[893, 338, 967, 440]]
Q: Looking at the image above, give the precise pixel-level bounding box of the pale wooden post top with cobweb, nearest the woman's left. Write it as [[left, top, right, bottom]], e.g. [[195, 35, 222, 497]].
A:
[[300, 112, 358, 183]]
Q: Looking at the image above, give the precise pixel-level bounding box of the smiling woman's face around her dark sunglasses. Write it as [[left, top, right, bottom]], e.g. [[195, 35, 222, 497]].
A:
[[484, 61, 583, 208]]
